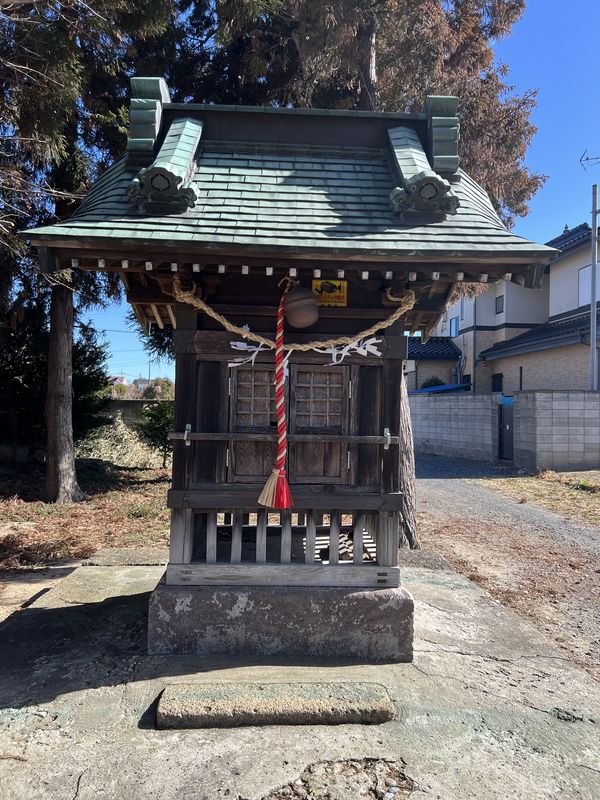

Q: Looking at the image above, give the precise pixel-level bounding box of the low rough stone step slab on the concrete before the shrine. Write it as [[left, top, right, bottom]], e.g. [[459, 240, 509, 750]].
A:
[[156, 682, 396, 728]]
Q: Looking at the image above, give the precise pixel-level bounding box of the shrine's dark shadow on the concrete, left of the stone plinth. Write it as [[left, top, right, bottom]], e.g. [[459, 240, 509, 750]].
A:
[[0, 580, 378, 712]]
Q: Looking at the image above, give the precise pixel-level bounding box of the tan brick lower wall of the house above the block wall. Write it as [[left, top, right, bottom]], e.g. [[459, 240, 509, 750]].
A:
[[485, 344, 590, 394]]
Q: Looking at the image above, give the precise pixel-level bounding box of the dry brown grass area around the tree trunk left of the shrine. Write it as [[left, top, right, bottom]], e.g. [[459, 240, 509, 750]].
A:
[[0, 460, 169, 569]]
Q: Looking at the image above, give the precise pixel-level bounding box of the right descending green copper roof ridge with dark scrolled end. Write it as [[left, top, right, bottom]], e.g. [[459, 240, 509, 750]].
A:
[[388, 125, 459, 222]]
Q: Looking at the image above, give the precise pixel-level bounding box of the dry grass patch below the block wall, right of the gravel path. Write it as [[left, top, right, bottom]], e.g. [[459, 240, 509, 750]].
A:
[[473, 470, 600, 525]]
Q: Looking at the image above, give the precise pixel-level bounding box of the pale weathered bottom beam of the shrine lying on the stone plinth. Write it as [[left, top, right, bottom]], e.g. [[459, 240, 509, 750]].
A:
[[166, 564, 400, 588]]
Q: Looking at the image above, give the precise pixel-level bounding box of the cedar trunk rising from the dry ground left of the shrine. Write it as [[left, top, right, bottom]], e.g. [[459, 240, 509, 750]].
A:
[[45, 284, 85, 503]]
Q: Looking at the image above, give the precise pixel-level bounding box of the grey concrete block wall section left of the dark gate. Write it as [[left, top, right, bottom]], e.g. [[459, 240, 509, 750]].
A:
[[410, 393, 500, 461]]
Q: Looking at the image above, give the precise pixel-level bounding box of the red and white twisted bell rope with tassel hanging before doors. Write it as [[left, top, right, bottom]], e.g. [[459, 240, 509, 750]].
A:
[[258, 279, 294, 508]]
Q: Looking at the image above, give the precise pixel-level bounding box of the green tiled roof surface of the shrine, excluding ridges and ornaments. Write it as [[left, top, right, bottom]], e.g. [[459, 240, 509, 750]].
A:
[[28, 145, 552, 256]]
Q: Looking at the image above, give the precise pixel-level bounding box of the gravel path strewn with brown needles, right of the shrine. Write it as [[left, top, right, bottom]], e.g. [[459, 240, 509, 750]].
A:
[[417, 456, 600, 680]]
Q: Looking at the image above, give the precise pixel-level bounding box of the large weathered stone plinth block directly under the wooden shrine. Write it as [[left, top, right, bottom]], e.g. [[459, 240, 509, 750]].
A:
[[148, 583, 414, 663]]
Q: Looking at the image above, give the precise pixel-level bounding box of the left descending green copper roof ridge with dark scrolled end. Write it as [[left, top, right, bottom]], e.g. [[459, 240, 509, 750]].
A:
[[127, 117, 203, 215]]
